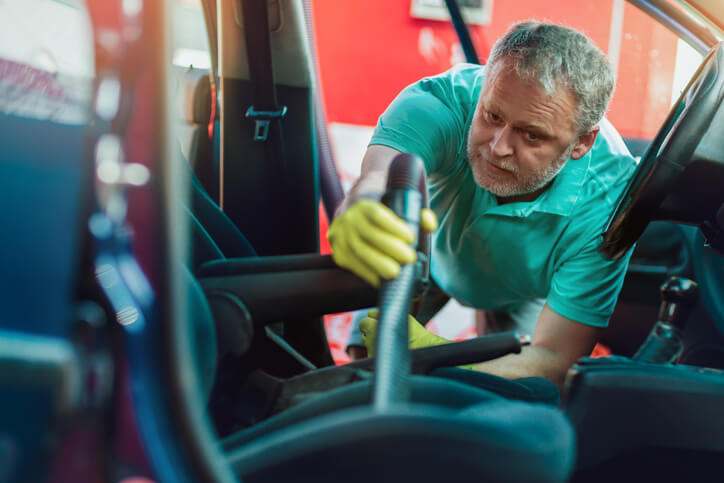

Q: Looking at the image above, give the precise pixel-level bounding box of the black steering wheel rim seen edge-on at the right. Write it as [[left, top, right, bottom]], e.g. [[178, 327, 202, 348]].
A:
[[601, 42, 724, 259]]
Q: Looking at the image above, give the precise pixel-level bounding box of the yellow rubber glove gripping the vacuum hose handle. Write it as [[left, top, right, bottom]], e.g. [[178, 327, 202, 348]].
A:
[[327, 199, 437, 287]]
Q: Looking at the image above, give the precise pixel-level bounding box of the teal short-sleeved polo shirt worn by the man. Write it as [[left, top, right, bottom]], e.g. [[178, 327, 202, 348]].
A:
[[370, 64, 636, 327]]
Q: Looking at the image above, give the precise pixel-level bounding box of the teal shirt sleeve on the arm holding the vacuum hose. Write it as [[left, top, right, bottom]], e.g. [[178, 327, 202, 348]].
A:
[[370, 69, 476, 174]]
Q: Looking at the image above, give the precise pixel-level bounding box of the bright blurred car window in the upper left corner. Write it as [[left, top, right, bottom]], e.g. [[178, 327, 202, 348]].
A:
[[0, 0, 95, 125]]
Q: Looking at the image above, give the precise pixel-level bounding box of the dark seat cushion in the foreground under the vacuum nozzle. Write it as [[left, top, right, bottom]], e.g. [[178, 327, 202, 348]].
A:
[[227, 400, 575, 483]]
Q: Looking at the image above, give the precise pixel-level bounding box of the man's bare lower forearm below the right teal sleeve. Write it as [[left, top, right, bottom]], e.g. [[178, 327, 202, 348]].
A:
[[476, 304, 600, 388]]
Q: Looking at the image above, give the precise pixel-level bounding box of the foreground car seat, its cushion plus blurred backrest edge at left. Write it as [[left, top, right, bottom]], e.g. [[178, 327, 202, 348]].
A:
[[185, 253, 575, 483]]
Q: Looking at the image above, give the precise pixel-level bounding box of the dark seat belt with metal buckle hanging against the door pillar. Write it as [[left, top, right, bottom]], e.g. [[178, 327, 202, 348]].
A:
[[241, 0, 287, 144]]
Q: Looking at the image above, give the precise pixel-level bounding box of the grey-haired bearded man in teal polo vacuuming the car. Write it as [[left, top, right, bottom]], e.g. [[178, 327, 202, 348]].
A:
[[328, 21, 635, 385]]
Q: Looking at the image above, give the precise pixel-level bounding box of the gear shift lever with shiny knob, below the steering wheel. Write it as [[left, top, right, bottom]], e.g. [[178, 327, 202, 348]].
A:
[[633, 277, 699, 364]]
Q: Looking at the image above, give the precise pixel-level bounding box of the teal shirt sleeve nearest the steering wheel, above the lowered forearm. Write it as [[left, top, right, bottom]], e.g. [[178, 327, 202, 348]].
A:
[[547, 237, 633, 327]]
